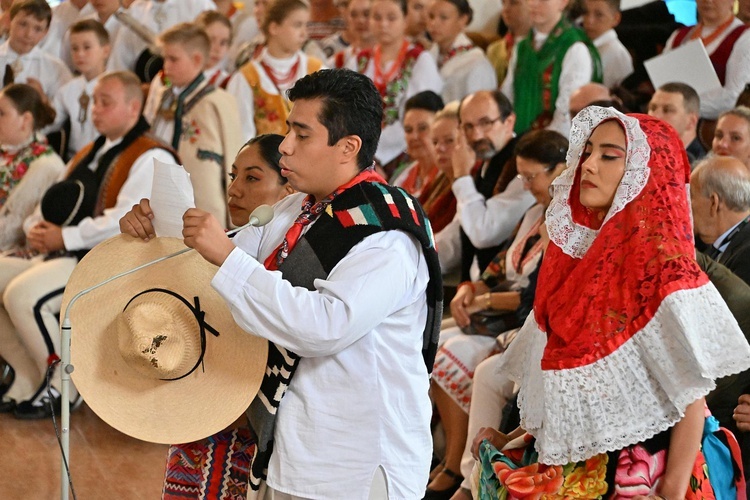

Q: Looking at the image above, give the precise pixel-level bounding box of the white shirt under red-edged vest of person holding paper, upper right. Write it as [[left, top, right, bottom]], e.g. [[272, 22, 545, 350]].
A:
[[664, 18, 750, 120]]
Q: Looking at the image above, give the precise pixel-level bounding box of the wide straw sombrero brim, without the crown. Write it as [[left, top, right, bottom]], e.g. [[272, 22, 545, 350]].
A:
[[61, 235, 268, 444]]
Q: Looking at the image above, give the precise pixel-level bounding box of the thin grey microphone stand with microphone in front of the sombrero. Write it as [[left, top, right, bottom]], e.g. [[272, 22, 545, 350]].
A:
[[60, 205, 273, 500]]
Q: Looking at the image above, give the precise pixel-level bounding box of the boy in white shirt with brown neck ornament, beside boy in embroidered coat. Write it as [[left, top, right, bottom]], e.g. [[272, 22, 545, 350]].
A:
[[45, 19, 111, 159]]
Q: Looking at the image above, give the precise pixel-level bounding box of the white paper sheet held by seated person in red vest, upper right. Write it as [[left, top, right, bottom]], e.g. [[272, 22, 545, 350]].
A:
[[643, 39, 721, 94]]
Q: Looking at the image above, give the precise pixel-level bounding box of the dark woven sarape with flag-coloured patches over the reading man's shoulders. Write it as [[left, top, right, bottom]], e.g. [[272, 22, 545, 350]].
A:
[[247, 182, 443, 490]]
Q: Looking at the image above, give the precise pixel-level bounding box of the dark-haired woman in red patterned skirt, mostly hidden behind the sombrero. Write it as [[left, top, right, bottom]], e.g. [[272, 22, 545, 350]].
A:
[[162, 134, 294, 500]]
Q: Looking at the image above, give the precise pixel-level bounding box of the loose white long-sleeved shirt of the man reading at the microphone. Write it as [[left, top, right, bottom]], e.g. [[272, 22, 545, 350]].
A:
[[211, 194, 432, 500]]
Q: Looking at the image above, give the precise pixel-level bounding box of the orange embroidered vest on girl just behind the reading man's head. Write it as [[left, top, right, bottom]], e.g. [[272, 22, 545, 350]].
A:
[[240, 57, 323, 135]]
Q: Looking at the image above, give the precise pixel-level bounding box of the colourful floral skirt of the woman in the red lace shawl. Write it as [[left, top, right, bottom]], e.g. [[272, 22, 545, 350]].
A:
[[472, 417, 745, 500]]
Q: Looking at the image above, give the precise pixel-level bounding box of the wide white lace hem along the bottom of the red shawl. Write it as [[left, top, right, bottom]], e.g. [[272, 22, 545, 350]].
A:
[[498, 283, 750, 465]]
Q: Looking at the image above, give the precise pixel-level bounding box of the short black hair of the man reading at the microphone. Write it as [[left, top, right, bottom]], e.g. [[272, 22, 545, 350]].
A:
[[287, 69, 383, 170]]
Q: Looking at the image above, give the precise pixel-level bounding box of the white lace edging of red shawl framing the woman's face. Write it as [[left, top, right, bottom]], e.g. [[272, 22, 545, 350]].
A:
[[547, 106, 651, 259]]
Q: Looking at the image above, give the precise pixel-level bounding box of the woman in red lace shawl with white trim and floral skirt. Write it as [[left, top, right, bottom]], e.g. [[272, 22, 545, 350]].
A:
[[477, 107, 750, 500]]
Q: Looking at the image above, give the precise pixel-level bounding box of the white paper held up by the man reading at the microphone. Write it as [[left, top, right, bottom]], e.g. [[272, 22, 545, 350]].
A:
[[151, 159, 195, 238]]
